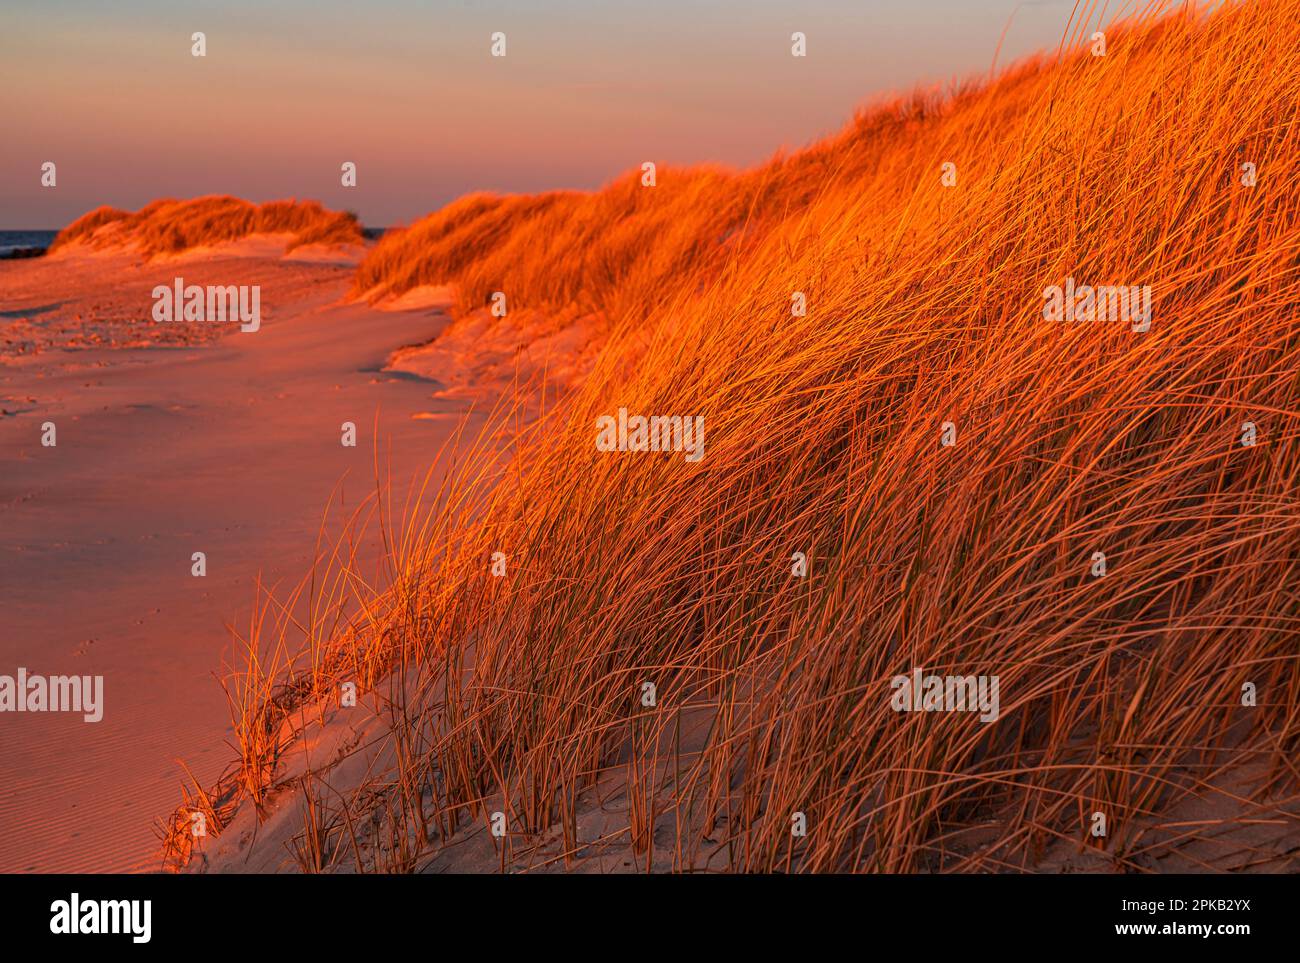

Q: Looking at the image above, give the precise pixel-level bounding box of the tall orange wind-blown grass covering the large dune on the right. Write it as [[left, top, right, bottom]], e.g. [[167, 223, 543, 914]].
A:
[[162, 0, 1300, 872]]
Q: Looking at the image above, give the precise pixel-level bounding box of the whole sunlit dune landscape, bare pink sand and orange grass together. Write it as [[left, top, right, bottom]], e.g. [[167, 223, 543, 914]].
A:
[[10, 0, 1300, 872]]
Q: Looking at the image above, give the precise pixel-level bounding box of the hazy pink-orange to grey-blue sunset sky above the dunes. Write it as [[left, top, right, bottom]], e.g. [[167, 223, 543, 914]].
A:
[[0, 0, 1075, 229]]
